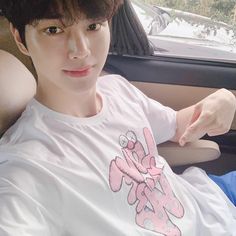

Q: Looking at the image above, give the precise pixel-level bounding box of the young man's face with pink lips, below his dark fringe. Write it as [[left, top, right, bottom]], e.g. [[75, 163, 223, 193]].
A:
[[25, 16, 110, 95]]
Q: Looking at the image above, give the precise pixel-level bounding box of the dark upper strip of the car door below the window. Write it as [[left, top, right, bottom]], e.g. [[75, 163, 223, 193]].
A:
[[105, 55, 236, 90]]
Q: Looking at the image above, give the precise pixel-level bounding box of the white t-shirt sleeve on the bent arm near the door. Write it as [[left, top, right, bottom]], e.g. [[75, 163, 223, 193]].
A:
[[109, 76, 177, 144]]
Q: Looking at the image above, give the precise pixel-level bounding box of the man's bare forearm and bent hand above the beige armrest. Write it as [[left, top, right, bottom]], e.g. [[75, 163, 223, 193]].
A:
[[171, 89, 236, 146]]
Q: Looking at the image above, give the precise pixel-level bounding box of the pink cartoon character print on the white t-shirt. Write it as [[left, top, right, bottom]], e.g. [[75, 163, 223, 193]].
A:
[[109, 128, 184, 236]]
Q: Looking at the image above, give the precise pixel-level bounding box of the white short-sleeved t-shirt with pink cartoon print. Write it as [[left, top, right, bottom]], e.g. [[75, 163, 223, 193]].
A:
[[0, 75, 236, 236]]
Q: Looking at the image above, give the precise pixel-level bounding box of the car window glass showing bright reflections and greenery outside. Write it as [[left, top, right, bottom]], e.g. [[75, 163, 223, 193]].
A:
[[132, 0, 236, 63]]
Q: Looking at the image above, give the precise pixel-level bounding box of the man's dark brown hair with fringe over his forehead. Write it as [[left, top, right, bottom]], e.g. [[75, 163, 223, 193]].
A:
[[0, 0, 123, 44]]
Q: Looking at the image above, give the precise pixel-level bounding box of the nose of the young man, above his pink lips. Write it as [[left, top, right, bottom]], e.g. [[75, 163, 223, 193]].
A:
[[68, 33, 90, 60]]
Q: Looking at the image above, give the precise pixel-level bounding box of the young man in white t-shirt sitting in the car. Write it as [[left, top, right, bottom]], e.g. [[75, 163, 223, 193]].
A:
[[0, 0, 236, 236]]
